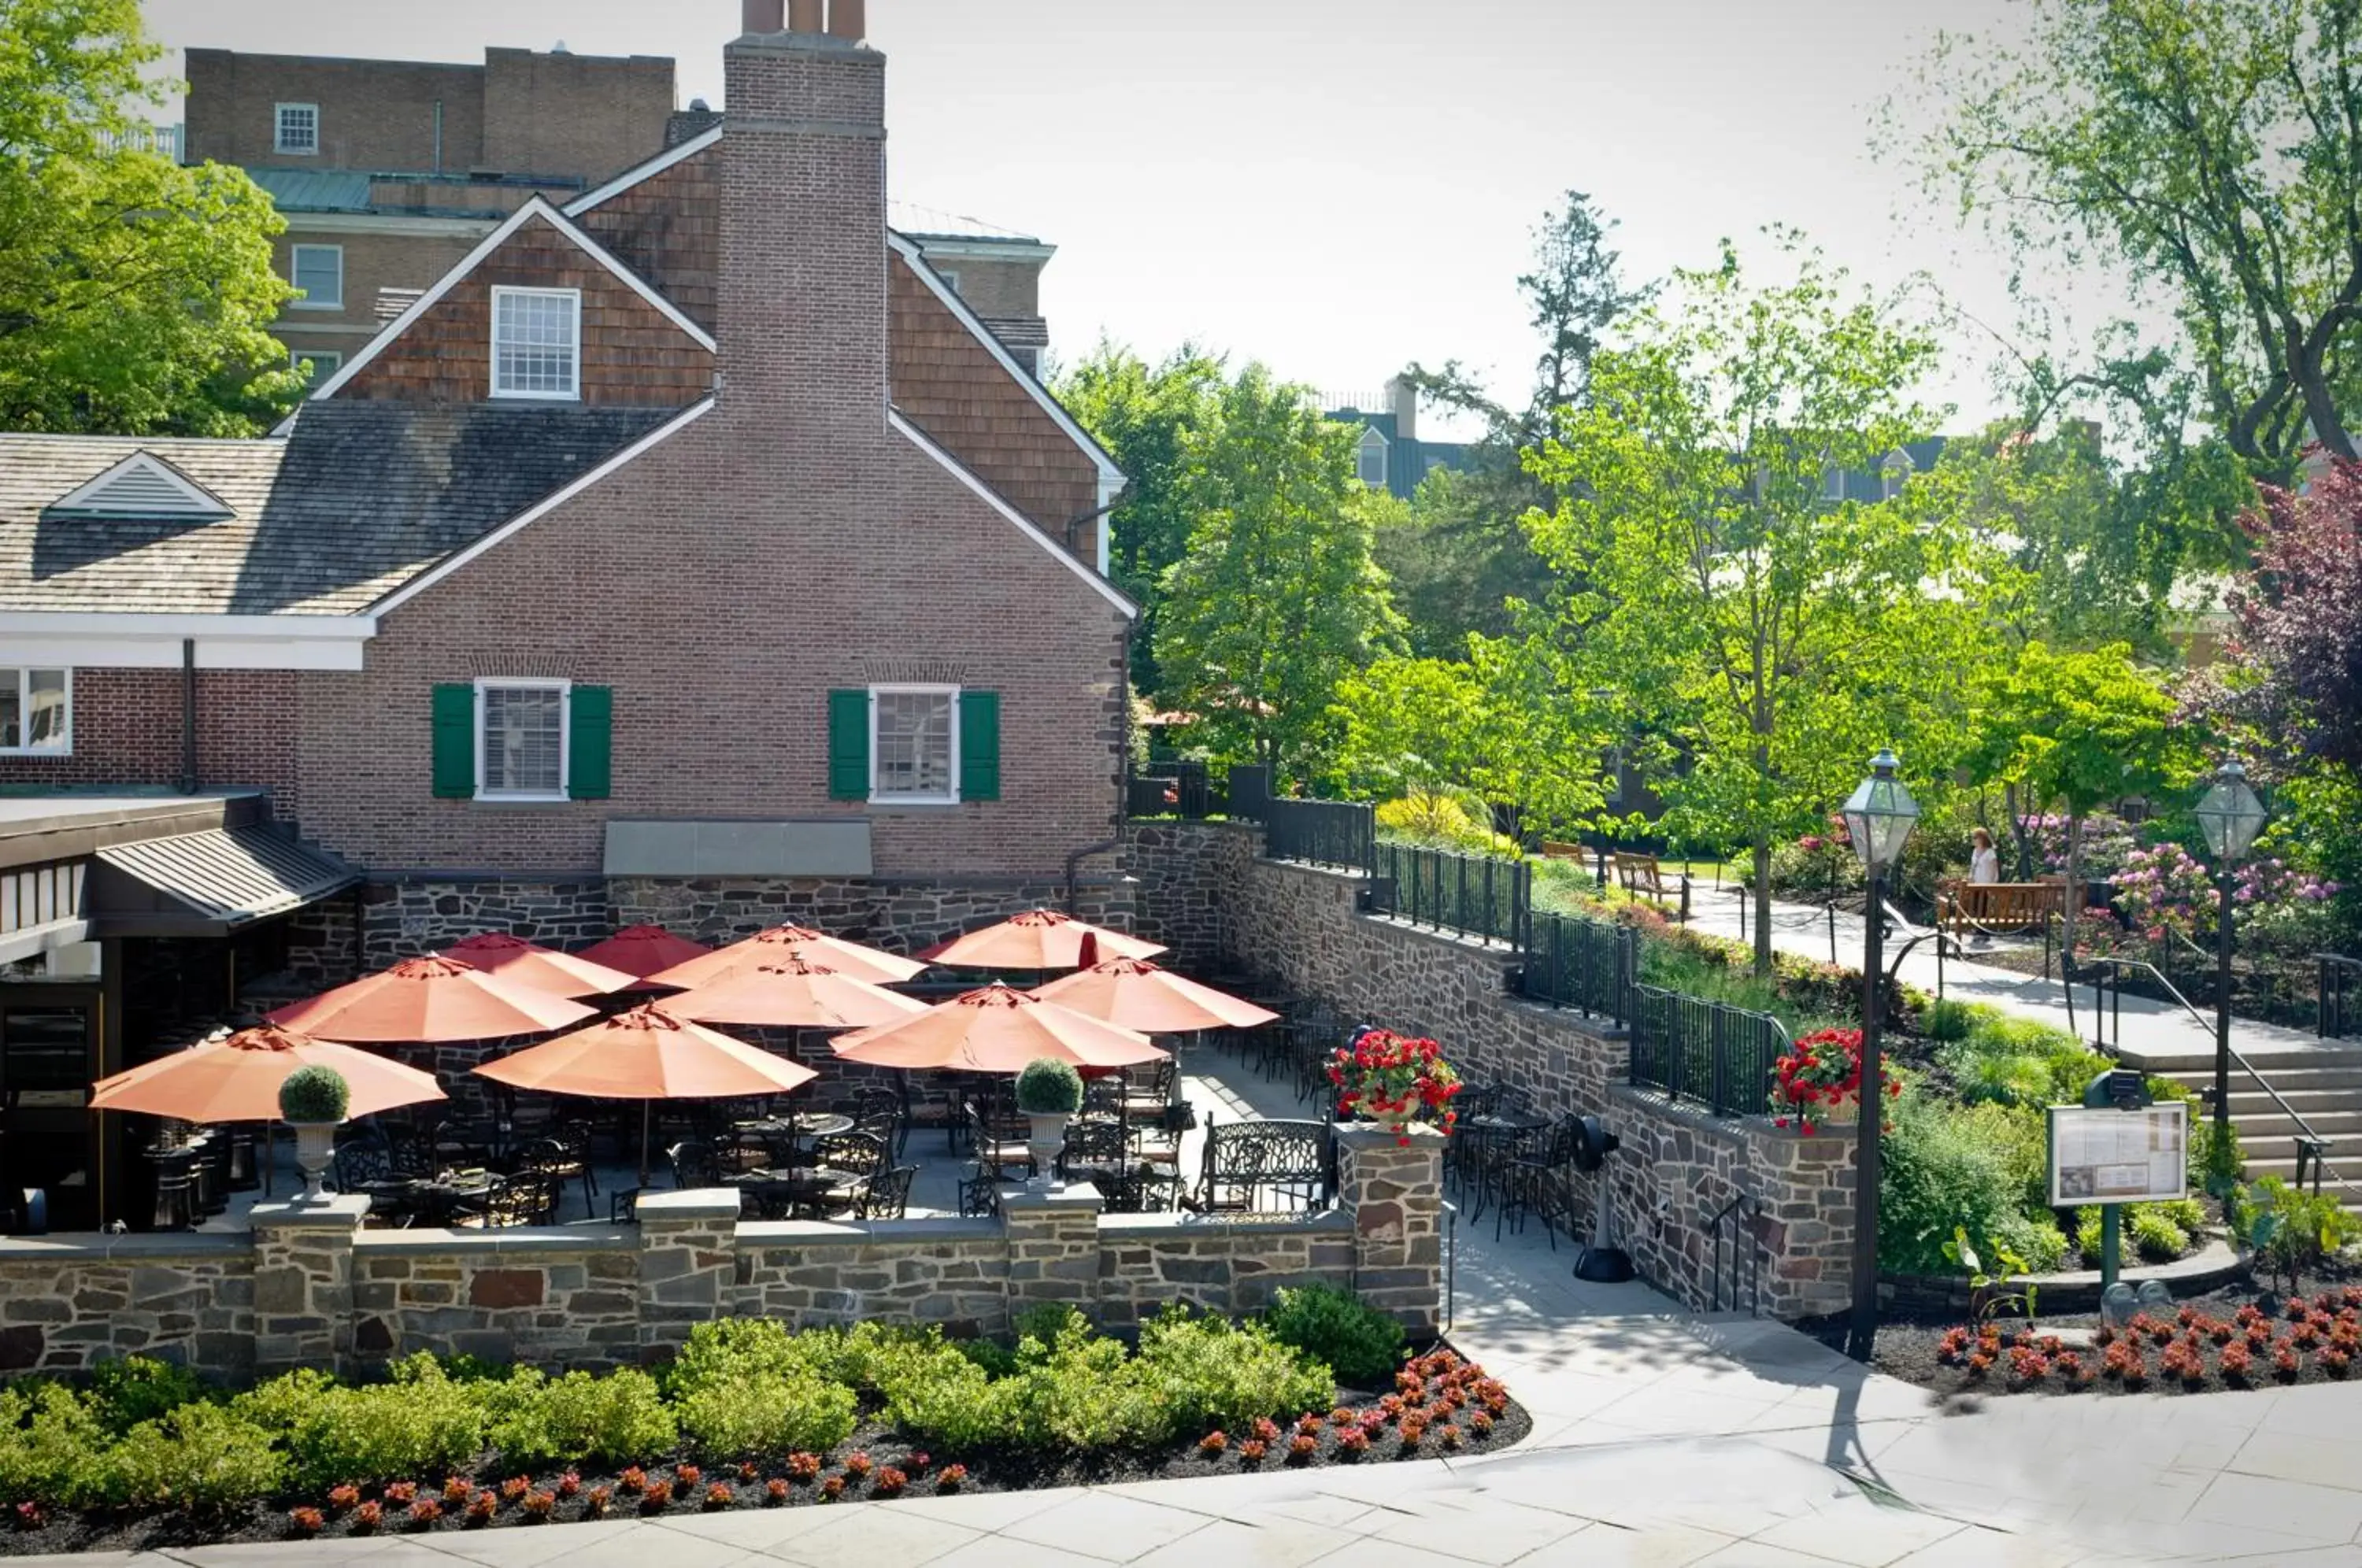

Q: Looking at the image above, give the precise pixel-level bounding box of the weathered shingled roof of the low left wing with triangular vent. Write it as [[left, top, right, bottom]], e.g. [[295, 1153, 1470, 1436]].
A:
[[0, 401, 678, 616]]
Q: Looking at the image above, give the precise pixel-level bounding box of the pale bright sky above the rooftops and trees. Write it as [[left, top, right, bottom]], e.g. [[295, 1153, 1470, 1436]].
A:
[[146, 0, 2060, 437]]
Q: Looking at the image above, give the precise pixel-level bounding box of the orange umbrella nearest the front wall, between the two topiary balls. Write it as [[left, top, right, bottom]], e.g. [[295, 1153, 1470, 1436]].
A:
[[477, 1004, 820, 1181]]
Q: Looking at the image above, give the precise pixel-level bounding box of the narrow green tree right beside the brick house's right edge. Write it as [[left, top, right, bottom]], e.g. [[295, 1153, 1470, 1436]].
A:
[[1058, 338, 1224, 692]]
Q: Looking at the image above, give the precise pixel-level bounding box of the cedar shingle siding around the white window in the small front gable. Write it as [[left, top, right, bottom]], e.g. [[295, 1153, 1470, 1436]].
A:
[[338, 217, 713, 409]]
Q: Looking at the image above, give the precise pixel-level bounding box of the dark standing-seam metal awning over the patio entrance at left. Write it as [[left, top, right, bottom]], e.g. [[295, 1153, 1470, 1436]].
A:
[[92, 827, 361, 937]]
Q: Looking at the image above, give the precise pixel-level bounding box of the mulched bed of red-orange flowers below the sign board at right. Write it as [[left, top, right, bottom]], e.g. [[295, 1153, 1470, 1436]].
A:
[[1797, 1270, 2362, 1403]]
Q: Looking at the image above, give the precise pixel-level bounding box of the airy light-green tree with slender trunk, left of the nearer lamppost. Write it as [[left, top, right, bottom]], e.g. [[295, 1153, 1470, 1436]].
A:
[[1528, 236, 1984, 968]]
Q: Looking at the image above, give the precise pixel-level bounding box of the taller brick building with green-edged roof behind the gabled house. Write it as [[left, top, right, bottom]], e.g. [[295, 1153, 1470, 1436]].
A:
[[182, 47, 1056, 378]]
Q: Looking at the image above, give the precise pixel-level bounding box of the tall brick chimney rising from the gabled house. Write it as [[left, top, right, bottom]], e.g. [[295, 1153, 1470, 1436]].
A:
[[718, 0, 886, 442]]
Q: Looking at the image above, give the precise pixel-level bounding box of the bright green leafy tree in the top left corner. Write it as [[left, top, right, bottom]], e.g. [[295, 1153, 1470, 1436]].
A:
[[0, 0, 302, 435]]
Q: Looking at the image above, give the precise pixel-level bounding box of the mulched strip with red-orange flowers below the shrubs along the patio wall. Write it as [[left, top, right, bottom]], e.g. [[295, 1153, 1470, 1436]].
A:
[[0, 1346, 1533, 1556]]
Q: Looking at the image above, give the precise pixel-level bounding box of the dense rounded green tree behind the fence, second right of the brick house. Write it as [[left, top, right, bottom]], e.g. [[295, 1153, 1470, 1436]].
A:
[[1155, 364, 1401, 784]]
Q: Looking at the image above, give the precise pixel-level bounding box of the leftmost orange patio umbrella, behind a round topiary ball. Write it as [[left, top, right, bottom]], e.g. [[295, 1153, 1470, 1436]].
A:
[[90, 1027, 444, 1124]]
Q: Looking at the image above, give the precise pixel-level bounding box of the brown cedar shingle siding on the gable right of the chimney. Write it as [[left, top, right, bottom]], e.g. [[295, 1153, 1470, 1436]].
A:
[[888, 255, 1098, 543]]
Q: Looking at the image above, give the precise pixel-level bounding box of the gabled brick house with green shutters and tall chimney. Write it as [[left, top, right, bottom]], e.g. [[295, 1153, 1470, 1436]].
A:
[[0, 0, 1134, 1228]]
